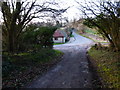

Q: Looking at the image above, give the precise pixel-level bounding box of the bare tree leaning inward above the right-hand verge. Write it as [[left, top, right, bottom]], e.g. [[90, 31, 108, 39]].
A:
[[77, 1, 120, 50]]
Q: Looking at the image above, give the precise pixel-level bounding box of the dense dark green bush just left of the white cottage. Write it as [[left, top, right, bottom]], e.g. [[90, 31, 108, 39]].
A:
[[19, 26, 57, 51]]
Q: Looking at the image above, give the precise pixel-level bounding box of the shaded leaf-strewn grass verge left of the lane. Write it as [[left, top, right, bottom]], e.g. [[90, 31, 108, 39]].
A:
[[2, 49, 63, 88]]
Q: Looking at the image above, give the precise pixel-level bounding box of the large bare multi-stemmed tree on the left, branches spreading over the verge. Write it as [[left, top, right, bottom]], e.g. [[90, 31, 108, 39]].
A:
[[1, 0, 67, 53]]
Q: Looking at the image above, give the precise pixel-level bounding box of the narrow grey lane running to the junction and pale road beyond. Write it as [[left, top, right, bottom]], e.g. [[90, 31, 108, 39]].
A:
[[28, 32, 93, 88]]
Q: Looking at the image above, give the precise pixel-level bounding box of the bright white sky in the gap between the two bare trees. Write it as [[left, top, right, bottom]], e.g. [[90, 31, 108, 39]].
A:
[[31, 0, 84, 21]]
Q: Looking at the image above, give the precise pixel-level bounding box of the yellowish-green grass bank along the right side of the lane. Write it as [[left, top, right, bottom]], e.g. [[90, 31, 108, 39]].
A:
[[88, 48, 120, 88]]
